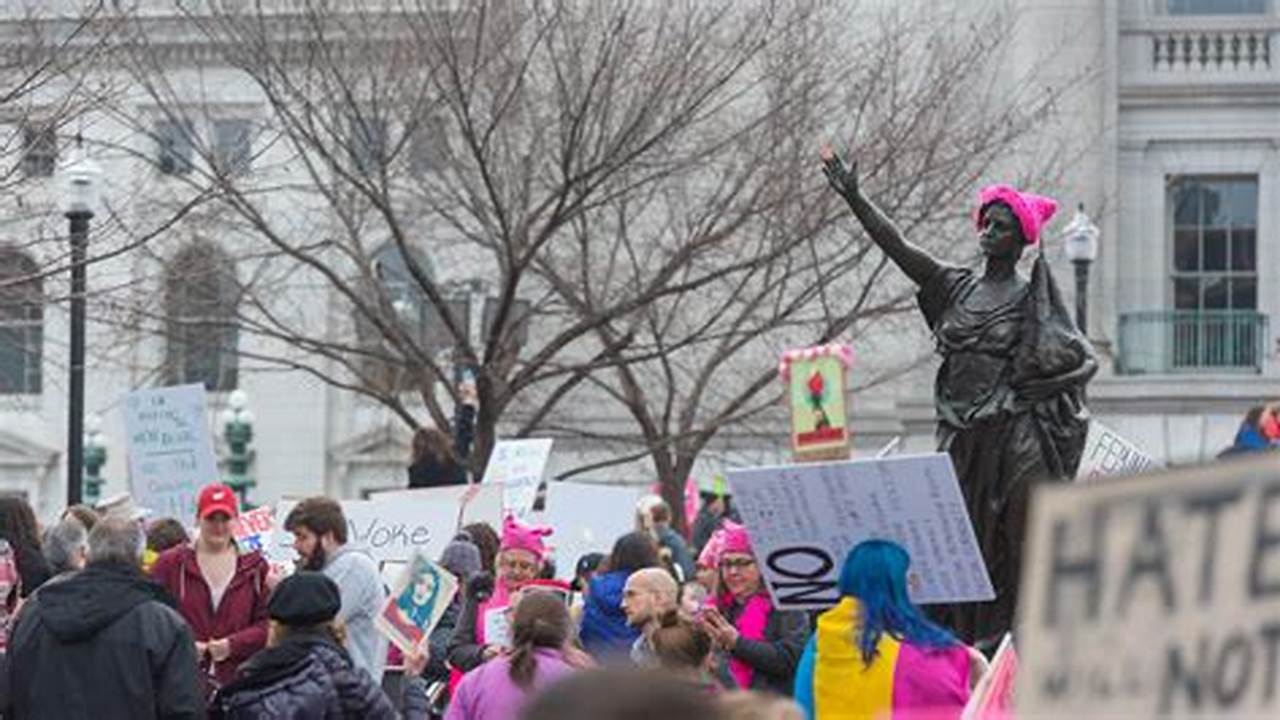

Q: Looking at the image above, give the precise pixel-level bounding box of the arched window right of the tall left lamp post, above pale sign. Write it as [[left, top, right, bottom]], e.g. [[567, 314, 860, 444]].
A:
[[165, 241, 239, 392]]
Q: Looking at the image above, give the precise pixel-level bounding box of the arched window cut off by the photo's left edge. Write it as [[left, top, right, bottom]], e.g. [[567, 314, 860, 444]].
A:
[[0, 249, 45, 395]]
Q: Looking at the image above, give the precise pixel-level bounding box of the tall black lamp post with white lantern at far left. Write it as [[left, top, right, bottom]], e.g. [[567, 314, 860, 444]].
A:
[[63, 136, 101, 505]]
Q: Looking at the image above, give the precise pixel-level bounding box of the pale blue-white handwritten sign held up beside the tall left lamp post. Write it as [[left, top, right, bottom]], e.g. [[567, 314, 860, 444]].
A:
[[122, 384, 219, 519]]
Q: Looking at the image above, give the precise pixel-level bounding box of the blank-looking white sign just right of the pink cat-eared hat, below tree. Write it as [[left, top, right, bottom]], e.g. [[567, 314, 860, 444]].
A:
[[530, 482, 643, 580]]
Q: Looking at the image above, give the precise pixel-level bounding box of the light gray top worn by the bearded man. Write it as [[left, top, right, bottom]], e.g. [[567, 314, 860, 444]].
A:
[[324, 546, 387, 683]]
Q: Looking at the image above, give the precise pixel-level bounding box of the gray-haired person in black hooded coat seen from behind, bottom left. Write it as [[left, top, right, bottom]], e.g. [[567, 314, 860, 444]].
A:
[[5, 518, 205, 720]]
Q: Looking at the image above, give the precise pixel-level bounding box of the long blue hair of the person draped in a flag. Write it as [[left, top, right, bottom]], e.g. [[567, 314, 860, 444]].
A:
[[840, 539, 959, 665]]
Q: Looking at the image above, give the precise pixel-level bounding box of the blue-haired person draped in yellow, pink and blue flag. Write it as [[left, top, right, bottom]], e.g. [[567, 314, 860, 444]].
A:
[[795, 541, 986, 720]]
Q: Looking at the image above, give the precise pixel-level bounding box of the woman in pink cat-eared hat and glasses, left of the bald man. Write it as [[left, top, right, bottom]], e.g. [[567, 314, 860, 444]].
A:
[[449, 515, 552, 671]]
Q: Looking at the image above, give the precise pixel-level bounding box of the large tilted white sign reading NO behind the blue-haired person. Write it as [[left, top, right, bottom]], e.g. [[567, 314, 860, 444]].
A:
[[728, 454, 996, 610]]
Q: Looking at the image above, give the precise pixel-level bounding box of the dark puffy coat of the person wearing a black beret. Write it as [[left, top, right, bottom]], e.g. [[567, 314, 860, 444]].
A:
[[209, 634, 426, 720]]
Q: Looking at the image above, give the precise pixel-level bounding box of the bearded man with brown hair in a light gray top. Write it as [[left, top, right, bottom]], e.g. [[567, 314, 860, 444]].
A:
[[284, 497, 387, 683]]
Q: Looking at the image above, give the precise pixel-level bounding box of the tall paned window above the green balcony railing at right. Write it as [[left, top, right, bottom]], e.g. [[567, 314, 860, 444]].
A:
[[1169, 176, 1263, 368]]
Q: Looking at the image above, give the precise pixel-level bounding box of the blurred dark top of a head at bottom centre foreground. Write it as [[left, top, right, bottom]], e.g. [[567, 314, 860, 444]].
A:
[[521, 669, 726, 720]]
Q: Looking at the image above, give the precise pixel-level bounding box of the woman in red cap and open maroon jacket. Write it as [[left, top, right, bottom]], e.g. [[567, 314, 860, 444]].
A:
[[151, 483, 270, 689]]
